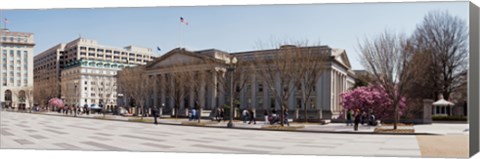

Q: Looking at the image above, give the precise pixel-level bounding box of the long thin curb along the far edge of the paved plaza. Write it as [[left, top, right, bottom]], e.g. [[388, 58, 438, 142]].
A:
[[4, 112, 440, 135]]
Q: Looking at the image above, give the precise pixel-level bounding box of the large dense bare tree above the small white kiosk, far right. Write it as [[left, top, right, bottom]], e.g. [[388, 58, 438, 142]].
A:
[[410, 11, 468, 99]]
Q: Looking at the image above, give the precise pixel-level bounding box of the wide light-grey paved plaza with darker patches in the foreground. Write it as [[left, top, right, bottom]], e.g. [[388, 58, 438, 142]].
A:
[[0, 111, 468, 157]]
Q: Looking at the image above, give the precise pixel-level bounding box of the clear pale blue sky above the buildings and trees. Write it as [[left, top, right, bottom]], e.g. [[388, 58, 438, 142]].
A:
[[0, 2, 468, 70]]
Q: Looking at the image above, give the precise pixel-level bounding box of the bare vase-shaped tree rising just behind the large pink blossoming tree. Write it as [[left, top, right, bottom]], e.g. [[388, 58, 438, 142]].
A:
[[359, 31, 415, 129]]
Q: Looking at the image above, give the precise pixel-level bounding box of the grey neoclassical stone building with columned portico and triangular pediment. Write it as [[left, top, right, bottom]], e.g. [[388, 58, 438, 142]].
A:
[[146, 45, 355, 119]]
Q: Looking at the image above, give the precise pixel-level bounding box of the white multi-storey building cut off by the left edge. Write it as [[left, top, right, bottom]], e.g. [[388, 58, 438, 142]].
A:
[[0, 29, 35, 109]]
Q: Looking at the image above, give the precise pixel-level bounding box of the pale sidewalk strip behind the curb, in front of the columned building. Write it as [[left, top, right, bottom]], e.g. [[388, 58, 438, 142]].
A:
[[23, 112, 468, 135]]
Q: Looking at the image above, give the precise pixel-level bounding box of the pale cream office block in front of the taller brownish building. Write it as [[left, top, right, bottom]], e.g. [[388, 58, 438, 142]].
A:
[[61, 59, 135, 110]]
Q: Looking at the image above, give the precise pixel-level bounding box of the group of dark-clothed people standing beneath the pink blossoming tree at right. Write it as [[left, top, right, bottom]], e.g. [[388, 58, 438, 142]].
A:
[[346, 109, 377, 131]]
